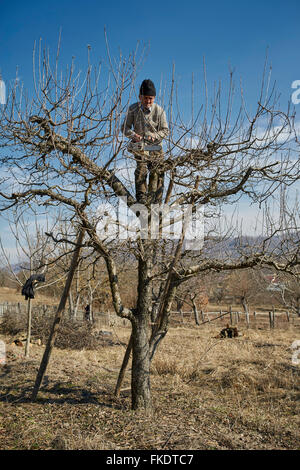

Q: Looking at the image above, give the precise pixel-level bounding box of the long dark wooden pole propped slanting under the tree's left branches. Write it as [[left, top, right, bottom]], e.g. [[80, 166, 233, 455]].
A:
[[31, 228, 84, 401]]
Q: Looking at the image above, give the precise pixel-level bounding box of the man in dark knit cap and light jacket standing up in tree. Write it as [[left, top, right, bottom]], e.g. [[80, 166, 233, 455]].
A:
[[122, 79, 169, 204]]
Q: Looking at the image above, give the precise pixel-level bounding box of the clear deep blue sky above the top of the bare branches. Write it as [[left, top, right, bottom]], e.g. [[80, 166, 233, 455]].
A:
[[0, 0, 300, 258]]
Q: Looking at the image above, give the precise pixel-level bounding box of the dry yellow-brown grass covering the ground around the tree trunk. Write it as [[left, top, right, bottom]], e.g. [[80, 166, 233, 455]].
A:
[[0, 325, 300, 450]]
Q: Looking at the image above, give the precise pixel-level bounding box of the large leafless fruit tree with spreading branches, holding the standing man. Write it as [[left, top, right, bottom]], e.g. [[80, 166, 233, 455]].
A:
[[0, 39, 299, 409]]
